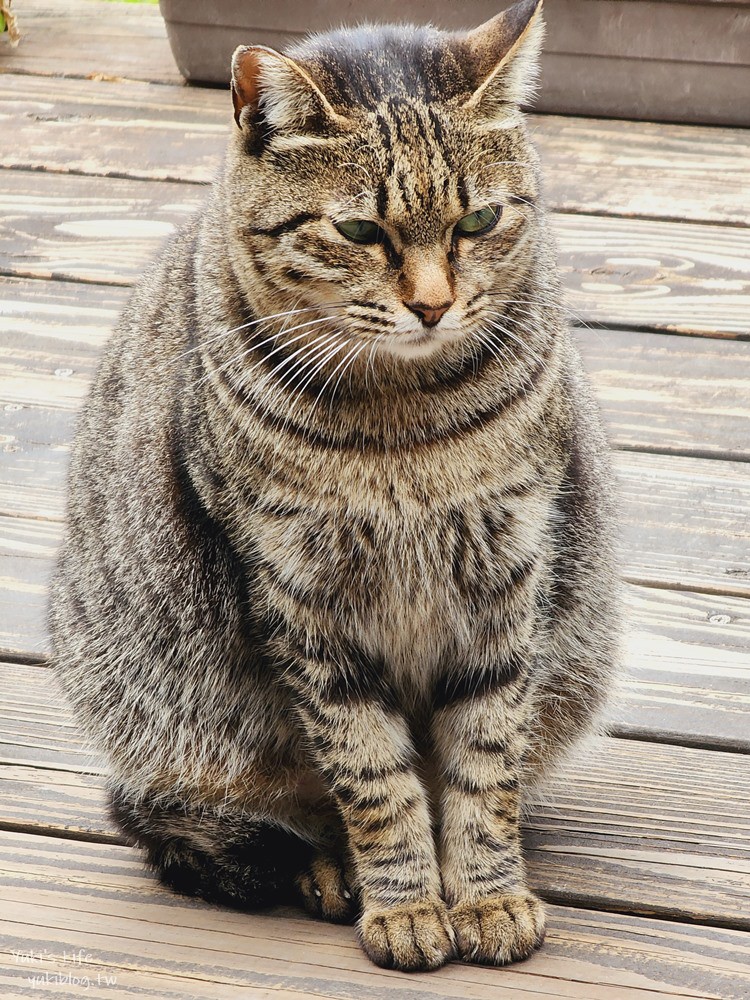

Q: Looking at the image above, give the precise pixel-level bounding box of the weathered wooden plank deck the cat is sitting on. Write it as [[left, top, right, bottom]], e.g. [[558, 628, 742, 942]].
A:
[[0, 0, 750, 1000]]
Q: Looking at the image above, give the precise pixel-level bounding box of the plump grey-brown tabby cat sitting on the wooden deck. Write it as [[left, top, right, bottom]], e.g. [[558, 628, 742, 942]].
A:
[[51, 0, 618, 970]]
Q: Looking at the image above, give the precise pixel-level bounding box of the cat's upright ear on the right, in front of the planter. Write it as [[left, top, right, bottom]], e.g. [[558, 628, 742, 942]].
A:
[[463, 0, 544, 119]]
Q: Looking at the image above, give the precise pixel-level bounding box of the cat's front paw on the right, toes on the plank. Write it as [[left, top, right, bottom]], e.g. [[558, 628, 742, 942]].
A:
[[449, 892, 544, 965]]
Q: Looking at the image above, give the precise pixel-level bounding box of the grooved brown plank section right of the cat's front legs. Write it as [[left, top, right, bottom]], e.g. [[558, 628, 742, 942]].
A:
[[526, 740, 750, 929]]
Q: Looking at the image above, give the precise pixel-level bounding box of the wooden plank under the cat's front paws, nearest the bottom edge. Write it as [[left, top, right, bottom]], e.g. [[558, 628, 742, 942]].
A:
[[0, 833, 750, 1000]]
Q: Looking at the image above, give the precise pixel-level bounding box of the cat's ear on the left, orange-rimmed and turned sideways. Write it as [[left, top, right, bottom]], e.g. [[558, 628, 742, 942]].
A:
[[232, 45, 346, 134]]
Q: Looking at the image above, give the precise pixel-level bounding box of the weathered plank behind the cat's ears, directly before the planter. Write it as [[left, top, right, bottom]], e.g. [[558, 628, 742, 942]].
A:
[[0, 70, 750, 224]]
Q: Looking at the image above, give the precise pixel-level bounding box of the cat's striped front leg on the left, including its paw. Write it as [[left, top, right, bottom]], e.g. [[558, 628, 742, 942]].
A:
[[287, 638, 454, 971]]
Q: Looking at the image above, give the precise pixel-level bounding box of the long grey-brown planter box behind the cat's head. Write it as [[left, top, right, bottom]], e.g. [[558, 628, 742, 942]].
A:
[[160, 0, 750, 125]]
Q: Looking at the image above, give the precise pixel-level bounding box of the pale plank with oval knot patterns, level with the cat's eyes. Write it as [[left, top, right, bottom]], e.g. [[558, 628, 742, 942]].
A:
[[0, 165, 750, 337]]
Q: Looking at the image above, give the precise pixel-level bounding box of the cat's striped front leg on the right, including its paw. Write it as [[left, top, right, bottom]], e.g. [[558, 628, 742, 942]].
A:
[[433, 653, 544, 965]]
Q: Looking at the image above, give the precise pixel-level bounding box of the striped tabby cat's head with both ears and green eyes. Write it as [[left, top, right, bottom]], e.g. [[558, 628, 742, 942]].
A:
[[224, 0, 543, 366]]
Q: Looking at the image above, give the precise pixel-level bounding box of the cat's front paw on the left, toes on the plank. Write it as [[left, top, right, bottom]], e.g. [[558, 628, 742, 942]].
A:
[[360, 901, 455, 972]]
